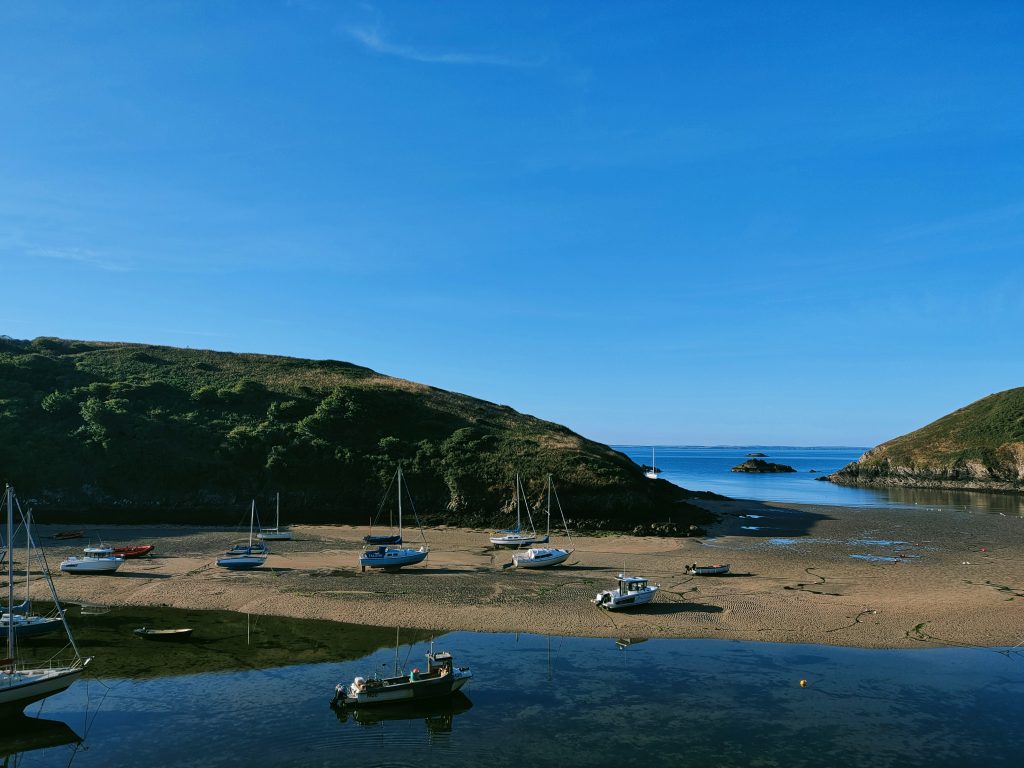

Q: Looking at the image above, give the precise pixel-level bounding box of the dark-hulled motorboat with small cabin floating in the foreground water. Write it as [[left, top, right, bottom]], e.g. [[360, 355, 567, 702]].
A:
[[331, 648, 473, 707]]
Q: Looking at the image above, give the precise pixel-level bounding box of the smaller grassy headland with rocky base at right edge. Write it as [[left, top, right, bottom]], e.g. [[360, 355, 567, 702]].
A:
[[825, 387, 1024, 490]]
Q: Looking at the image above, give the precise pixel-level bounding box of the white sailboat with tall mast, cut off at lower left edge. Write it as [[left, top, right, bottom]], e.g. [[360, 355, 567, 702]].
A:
[[0, 485, 91, 717]]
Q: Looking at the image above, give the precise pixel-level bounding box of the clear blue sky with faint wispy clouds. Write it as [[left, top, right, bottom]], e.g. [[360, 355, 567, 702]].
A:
[[0, 0, 1024, 445]]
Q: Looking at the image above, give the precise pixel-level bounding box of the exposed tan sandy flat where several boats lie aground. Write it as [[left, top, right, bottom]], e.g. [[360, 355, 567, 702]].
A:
[[34, 501, 1024, 648]]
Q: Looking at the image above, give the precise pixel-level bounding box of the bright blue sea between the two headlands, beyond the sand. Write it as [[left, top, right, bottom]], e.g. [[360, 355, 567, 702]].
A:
[[614, 445, 1024, 515]]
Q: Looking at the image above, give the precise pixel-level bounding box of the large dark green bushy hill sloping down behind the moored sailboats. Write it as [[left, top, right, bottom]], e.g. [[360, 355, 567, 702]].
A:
[[0, 337, 709, 530]]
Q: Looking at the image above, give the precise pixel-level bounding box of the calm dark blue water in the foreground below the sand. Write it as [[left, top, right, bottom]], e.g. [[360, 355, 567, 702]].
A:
[[0, 606, 1024, 768]]
